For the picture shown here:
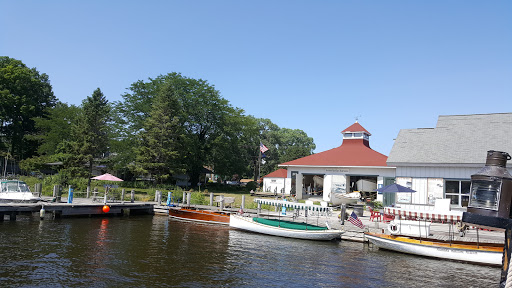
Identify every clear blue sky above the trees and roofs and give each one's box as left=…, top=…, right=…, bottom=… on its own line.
left=0, top=0, right=512, bottom=155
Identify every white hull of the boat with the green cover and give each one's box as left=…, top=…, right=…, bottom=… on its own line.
left=229, top=214, right=343, bottom=240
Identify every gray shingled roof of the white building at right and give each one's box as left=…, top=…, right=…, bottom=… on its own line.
left=387, top=113, right=512, bottom=167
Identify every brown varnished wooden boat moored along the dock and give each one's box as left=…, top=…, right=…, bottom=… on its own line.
left=169, top=207, right=229, bottom=225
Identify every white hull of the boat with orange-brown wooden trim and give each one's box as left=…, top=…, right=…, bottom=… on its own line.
left=365, top=234, right=503, bottom=265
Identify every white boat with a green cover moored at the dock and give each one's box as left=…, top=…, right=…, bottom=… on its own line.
left=229, top=214, right=343, bottom=240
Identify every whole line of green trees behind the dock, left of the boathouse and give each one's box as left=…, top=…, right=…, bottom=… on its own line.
left=0, top=57, right=315, bottom=184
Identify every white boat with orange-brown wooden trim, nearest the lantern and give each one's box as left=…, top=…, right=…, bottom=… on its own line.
left=365, top=232, right=504, bottom=266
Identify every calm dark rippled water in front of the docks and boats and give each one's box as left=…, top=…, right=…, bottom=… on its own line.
left=0, top=216, right=500, bottom=287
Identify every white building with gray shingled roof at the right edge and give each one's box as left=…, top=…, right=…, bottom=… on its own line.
left=385, top=113, right=512, bottom=208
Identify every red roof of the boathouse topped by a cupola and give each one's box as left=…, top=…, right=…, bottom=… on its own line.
left=281, top=139, right=388, bottom=166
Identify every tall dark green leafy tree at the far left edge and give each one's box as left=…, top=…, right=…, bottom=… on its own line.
left=0, top=57, right=56, bottom=160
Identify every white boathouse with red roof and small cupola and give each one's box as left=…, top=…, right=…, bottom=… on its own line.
left=279, top=121, right=395, bottom=202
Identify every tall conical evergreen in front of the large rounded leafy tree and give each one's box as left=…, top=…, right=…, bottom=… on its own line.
left=134, top=85, right=185, bottom=183
